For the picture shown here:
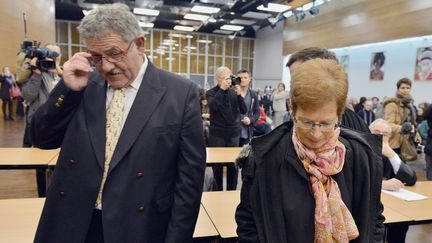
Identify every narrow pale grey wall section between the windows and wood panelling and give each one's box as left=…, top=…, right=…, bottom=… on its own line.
left=252, top=21, right=283, bottom=89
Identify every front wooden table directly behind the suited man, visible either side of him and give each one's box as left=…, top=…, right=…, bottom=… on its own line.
left=0, top=198, right=219, bottom=243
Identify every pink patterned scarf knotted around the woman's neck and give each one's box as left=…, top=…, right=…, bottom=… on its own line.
left=292, top=127, right=359, bottom=243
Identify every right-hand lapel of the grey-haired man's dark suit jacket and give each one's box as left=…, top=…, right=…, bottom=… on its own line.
left=108, top=62, right=166, bottom=173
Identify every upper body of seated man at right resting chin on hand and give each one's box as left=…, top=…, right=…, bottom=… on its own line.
left=369, top=118, right=417, bottom=191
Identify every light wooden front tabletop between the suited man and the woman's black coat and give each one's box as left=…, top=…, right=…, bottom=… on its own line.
left=201, top=190, right=240, bottom=239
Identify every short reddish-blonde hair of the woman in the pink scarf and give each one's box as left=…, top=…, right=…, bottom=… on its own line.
left=290, top=58, right=348, bottom=118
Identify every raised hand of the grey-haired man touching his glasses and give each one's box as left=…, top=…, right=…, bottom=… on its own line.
left=63, top=52, right=93, bottom=91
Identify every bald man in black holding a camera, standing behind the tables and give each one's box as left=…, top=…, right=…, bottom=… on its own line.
left=206, top=67, right=247, bottom=190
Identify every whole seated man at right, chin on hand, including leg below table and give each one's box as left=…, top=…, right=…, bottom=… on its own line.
left=369, top=119, right=417, bottom=243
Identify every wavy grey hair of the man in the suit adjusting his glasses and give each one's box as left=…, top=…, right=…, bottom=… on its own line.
left=78, top=3, right=142, bottom=42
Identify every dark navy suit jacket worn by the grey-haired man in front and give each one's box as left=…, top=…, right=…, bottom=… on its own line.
left=30, top=63, right=205, bottom=243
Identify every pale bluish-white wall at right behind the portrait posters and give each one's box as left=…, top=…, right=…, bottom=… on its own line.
left=282, top=36, right=432, bottom=104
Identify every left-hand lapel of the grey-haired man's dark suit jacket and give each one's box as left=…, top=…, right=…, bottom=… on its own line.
left=84, top=77, right=106, bottom=168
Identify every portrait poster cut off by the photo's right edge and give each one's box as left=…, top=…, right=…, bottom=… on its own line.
left=414, top=46, right=432, bottom=81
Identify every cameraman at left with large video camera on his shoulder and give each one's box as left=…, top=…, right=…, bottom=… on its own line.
left=22, top=44, right=62, bottom=197
